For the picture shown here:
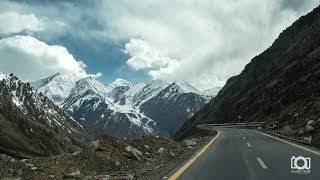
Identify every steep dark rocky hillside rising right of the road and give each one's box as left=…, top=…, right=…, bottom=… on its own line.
left=176, top=7, right=320, bottom=141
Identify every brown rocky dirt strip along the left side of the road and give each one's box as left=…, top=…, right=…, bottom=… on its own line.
left=0, top=131, right=212, bottom=180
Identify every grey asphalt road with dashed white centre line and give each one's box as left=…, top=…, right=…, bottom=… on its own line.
left=168, top=128, right=320, bottom=180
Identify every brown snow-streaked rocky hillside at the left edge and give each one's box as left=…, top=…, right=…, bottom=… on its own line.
left=0, top=73, right=91, bottom=157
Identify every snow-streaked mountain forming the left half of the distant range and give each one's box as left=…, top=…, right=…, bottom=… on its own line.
left=62, top=77, right=158, bottom=137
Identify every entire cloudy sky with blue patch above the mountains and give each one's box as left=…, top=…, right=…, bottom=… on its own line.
left=0, top=0, right=320, bottom=89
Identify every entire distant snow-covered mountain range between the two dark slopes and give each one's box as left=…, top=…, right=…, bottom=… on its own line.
left=31, top=73, right=217, bottom=137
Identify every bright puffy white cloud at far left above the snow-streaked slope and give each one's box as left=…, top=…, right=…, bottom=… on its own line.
left=0, top=35, right=101, bottom=81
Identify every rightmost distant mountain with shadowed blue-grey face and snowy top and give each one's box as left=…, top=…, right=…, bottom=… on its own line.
left=140, top=82, right=210, bottom=135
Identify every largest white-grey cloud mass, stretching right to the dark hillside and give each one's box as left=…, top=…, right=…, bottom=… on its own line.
left=99, top=0, right=319, bottom=89
